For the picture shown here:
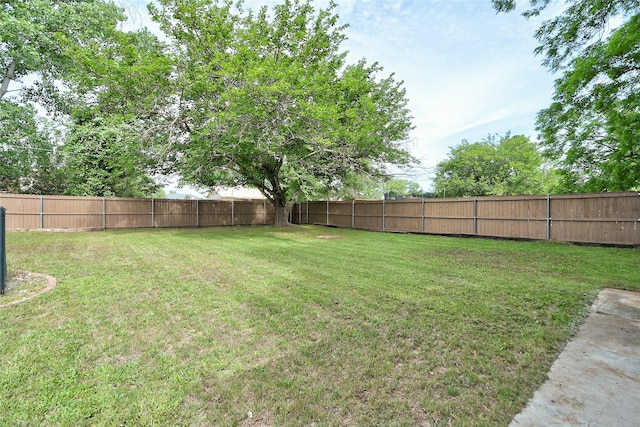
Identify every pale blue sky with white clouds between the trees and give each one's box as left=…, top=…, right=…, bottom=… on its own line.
left=127, top=0, right=554, bottom=190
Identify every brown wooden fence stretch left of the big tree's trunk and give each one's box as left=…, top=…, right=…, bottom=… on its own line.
left=0, top=193, right=274, bottom=230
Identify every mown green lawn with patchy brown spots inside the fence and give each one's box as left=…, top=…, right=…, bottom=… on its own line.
left=0, top=226, right=640, bottom=426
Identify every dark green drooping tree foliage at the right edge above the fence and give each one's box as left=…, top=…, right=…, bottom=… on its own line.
left=492, top=0, right=640, bottom=191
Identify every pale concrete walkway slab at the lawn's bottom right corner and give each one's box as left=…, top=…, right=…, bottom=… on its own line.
left=510, top=289, right=640, bottom=427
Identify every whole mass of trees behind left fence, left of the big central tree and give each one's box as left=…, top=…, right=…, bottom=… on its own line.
left=0, top=0, right=172, bottom=196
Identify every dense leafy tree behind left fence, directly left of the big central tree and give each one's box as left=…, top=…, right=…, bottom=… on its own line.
left=62, top=30, right=175, bottom=197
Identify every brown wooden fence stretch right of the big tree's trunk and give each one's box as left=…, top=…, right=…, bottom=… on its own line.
left=292, top=193, right=640, bottom=247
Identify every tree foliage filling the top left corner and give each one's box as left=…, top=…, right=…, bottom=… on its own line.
left=0, top=0, right=124, bottom=106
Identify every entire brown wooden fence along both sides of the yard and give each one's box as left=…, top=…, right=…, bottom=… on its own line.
left=0, top=193, right=640, bottom=246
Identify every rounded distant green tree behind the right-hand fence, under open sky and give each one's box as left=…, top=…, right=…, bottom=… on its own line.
left=434, top=134, right=554, bottom=197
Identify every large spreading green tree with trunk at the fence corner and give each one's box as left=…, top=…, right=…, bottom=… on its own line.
left=150, top=0, right=413, bottom=226
